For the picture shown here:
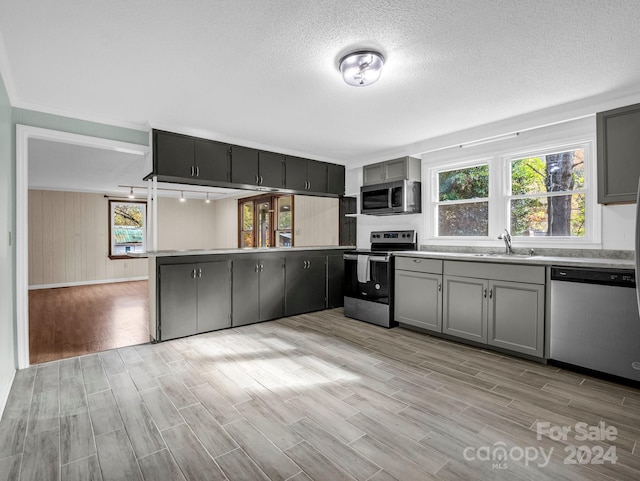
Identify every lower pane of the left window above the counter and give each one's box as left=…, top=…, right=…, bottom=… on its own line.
left=438, top=202, right=489, bottom=236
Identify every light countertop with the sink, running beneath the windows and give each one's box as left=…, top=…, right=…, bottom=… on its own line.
left=394, top=251, right=635, bottom=269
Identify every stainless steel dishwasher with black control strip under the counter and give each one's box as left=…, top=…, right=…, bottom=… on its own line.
left=549, top=267, right=640, bottom=381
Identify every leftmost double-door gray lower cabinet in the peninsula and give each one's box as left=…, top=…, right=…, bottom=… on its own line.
left=158, top=261, right=231, bottom=341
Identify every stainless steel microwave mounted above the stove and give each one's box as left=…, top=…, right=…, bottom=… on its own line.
left=360, top=180, right=422, bottom=215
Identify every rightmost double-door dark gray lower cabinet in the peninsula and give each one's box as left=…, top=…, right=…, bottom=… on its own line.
left=285, top=256, right=327, bottom=316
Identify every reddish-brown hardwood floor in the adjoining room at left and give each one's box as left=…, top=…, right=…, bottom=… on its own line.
left=29, top=281, right=149, bottom=364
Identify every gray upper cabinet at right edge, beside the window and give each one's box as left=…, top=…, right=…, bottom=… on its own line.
left=596, top=104, right=640, bottom=204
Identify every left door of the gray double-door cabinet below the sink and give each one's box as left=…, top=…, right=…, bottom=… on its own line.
left=442, top=276, right=489, bottom=343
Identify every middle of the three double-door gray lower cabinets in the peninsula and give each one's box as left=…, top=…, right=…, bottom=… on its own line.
left=232, top=257, right=284, bottom=327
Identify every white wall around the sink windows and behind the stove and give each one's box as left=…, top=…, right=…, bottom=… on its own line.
left=346, top=116, right=635, bottom=250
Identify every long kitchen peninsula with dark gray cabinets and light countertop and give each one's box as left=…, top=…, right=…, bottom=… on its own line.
left=131, top=246, right=352, bottom=342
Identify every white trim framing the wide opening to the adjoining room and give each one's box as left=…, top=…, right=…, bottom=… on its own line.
left=15, top=125, right=152, bottom=369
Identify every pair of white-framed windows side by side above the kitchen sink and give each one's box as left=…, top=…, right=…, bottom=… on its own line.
left=429, top=142, right=599, bottom=244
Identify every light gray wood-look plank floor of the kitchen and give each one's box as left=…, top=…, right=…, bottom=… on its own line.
left=0, top=309, right=640, bottom=481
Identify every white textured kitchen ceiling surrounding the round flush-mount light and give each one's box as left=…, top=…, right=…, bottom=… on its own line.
left=0, top=0, right=640, bottom=164
